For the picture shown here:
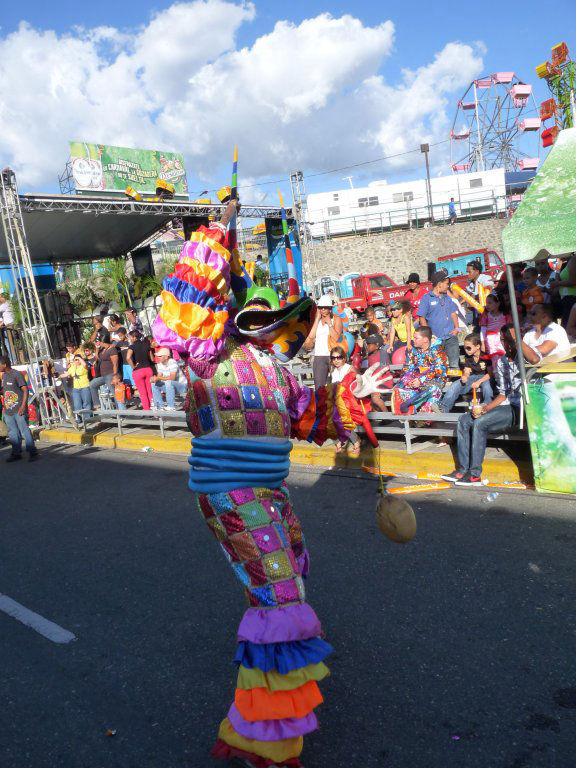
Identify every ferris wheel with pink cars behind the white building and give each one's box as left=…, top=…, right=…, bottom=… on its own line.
left=450, top=72, right=541, bottom=173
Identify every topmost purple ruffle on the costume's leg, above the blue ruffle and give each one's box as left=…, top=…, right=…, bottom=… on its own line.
left=238, top=603, right=322, bottom=644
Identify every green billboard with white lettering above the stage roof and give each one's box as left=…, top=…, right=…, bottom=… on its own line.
left=70, top=141, right=188, bottom=199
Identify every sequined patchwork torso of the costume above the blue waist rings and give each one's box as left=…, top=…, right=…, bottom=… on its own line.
left=186, top=339, right=290, bottom=437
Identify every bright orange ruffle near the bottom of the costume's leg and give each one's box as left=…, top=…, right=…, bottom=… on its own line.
left=234, top=680, right=324, bottom=722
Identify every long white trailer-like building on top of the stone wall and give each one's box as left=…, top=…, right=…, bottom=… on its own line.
left=307, top=168, right=506, bottom=237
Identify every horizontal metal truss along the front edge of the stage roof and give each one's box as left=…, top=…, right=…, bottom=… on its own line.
left=20, top=195, right=292, bottom=219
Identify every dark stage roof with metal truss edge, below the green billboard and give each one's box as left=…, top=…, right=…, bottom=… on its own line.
left=0, top=195, right=291, bottom=264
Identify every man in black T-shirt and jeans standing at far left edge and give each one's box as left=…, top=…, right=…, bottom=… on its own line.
left=0, top=356, right=38, bottom=463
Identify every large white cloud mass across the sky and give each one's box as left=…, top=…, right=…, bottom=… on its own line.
left=0, top=0, right=483, bottom=195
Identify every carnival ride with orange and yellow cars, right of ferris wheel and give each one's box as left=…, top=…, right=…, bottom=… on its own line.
left=536, top=43, right=576, bottom=147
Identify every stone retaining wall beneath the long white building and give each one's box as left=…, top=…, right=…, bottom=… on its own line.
left=310, top=219, right=508, bottom=283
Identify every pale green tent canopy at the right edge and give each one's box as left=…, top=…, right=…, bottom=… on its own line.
left=502, top=128, right=576, bottom=264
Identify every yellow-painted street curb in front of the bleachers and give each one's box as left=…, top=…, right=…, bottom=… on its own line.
left=40, top=429, right=533, bottom=485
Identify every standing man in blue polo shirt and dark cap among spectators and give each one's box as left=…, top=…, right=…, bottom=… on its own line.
left=418, top=269, right=460, bottom=368
